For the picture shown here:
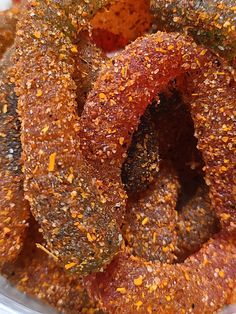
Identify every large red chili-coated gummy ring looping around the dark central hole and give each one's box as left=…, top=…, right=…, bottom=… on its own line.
left=80, top=32, right=236, bottom=313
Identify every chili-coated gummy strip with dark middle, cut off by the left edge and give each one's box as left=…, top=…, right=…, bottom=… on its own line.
left=0, top=47, right=29, bottom=268
